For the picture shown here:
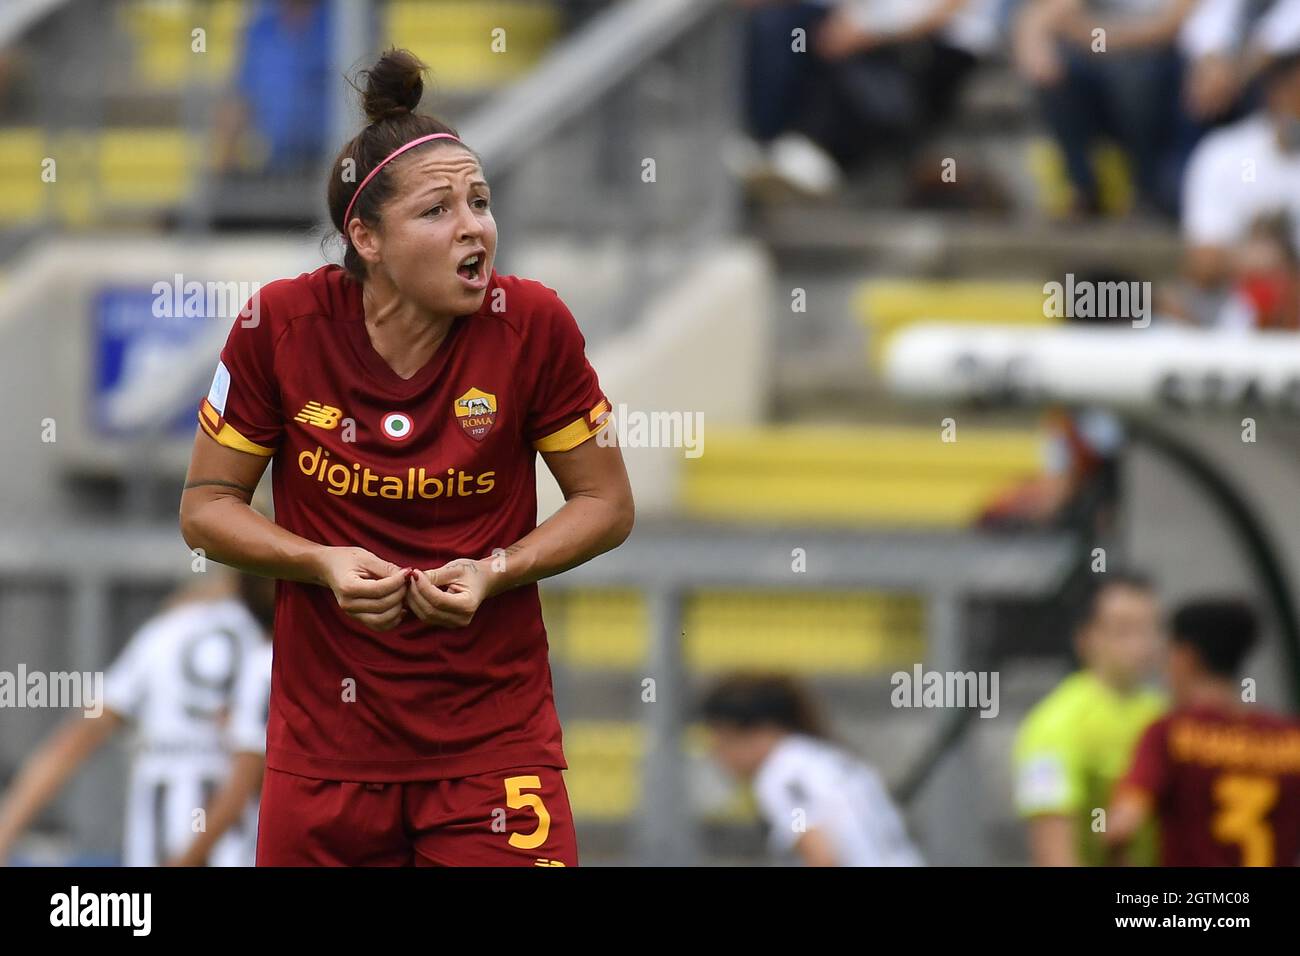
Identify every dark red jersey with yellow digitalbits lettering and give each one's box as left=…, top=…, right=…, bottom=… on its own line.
left=199, top=265, right=610, bottom=782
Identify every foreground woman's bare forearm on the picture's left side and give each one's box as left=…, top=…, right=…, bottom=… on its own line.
left=181, top=488, right=326, bottom=584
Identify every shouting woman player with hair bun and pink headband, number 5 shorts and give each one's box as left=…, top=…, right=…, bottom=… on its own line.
left=181, top=51, right=633, bottom=866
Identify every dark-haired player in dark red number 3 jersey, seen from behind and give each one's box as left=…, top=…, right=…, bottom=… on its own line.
left=1106, top=600, right=1300, bottom=866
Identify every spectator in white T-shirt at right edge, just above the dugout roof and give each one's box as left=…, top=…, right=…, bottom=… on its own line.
left=1183, top=49, right=1300, bottom=304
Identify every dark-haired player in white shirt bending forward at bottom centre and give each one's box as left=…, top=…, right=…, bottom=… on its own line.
left=701, top=674, right=923, bottom=866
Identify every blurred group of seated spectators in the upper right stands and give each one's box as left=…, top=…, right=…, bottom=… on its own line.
left=732, top=0, right=1300, bottom=329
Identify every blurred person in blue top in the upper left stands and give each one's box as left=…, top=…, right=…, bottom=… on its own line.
left=215, top=0, right=332, bottom=174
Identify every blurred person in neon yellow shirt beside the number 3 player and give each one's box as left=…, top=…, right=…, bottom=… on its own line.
left=1015, top=571, right=1165, bottom=866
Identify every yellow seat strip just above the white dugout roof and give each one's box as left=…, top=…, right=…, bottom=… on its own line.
left=853, top=280, right=1060, bottom=369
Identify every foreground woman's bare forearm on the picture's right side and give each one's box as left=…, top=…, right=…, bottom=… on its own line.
left=478, top=494, right=634, bottom=596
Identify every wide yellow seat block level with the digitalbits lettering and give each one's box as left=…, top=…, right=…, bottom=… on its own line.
left=681, top=423, right=1041, bottom=528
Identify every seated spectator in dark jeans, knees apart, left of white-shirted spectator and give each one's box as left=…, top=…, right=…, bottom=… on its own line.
left=1014, top=0, right=1197, bottom=216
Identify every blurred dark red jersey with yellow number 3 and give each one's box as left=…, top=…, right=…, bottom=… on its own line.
left=1119, top=706, right=1300, bottom=866
